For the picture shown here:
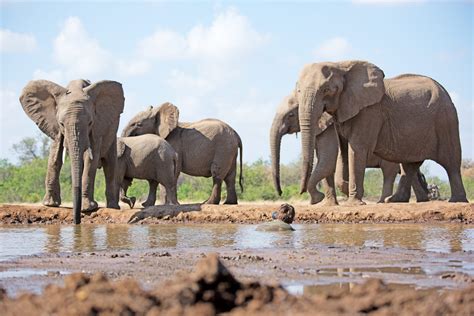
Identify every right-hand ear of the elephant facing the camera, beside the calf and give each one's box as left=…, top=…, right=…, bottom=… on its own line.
left=84, top=80, right=125, bottom=135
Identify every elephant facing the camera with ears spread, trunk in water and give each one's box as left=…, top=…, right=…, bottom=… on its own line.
left=20, top=80, right=125, bottom=224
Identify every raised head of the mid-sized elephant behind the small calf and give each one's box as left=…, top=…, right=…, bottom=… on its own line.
left=122, top=102, right=179, bottom=138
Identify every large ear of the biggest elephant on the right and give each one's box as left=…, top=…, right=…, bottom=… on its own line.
left=336, top=61, right=385, bottom=123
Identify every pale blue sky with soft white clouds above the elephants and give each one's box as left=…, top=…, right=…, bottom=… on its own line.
left=0, top=0, right=474, bottom=178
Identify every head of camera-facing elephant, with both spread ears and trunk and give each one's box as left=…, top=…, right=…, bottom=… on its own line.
left=20, top=80, right=125, bottom=223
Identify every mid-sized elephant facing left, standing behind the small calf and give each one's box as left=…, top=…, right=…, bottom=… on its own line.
left=122, top=102, right=243, bottom=204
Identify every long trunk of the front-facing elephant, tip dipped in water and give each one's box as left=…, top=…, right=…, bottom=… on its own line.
left=65, top=125, right=88, bottom=224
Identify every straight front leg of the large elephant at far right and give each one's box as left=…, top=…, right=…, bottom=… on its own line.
left=347, top=144, right=367, bottom=205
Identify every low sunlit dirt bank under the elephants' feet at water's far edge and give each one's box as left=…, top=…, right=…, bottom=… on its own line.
left=0, top=201, right=474, bottom=224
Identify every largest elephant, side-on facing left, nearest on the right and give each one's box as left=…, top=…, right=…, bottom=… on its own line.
left=296, top=61, right=467, bottom=204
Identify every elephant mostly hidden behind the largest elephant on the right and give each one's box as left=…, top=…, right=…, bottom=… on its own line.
left=270, top=93, right=429, bottom=205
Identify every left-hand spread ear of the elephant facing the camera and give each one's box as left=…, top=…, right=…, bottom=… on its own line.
left=20, top=80, right=67, bottom=139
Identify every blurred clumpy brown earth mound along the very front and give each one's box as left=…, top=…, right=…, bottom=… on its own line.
left=0, top=254, right=474, bottom=315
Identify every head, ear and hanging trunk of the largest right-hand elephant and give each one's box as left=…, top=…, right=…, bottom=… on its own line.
left=296, top=61, right=385, bottom=192
